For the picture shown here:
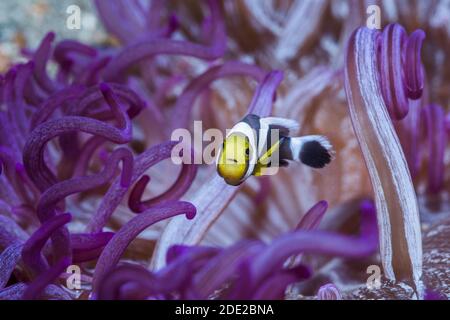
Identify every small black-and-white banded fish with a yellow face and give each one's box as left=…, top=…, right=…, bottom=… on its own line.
left=216, top=114, right=333, bottom=186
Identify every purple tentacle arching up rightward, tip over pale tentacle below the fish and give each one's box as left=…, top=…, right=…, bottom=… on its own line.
left=92, top=201, right=196, bottom=291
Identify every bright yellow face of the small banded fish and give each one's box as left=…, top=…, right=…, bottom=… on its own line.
left=217, top=134, right=251, bottom=186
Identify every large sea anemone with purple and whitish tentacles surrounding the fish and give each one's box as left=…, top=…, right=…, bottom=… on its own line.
left=0, top=0, right=450, bottom=300
